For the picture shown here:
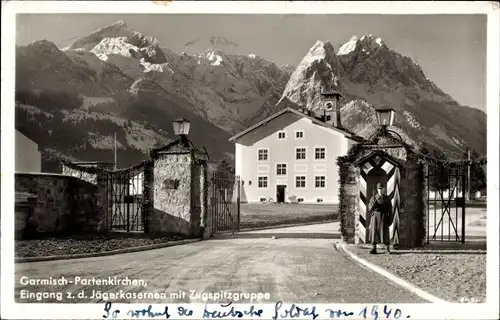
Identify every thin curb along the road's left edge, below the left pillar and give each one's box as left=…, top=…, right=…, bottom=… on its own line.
left=14, top=239, right=203, bottom=263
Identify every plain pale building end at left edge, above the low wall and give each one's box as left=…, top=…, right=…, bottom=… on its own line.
left=15, top=130, right=42, bottom=172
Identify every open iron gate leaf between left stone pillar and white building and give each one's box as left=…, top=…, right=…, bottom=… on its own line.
left=209, top=172, right=240, bottom=235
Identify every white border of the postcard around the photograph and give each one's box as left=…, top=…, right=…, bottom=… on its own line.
left=1, top=1, right=500, bottom=319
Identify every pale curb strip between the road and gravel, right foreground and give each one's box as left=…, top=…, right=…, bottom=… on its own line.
left=335, top=242, right=450, bottom=303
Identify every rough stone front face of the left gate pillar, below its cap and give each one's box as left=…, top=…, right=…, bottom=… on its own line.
left=147, top=153, right=193, bottom=235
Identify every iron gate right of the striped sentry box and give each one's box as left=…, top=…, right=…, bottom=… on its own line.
left=426, top=162, right=467, bottom=243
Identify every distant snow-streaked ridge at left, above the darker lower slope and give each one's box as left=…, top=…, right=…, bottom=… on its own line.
left=60, top=21, right=290, bottom=133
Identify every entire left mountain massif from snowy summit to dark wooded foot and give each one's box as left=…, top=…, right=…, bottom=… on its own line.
left=16, top=21, right=290, bottom=168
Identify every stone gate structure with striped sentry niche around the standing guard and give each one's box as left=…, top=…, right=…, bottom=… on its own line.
left=337, top=128, right=427, bottom=248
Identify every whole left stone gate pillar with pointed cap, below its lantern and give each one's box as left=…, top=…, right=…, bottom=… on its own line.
left=147, top=137, right=207, bottom=237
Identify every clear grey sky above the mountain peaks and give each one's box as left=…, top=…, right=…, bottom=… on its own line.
left=16, top=14, right=487, bottom=112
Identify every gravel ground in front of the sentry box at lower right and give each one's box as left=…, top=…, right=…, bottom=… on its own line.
left=349, top=245, right=486, bottom=303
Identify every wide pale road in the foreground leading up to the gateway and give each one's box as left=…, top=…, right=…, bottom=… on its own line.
left=15, top=238, right=424, bottom=303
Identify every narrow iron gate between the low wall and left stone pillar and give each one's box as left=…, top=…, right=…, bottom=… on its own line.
left=104, top=168, right=145, bottom=232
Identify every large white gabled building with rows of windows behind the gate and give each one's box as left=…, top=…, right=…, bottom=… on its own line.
left=230, top=107, right=359, bottom=204
